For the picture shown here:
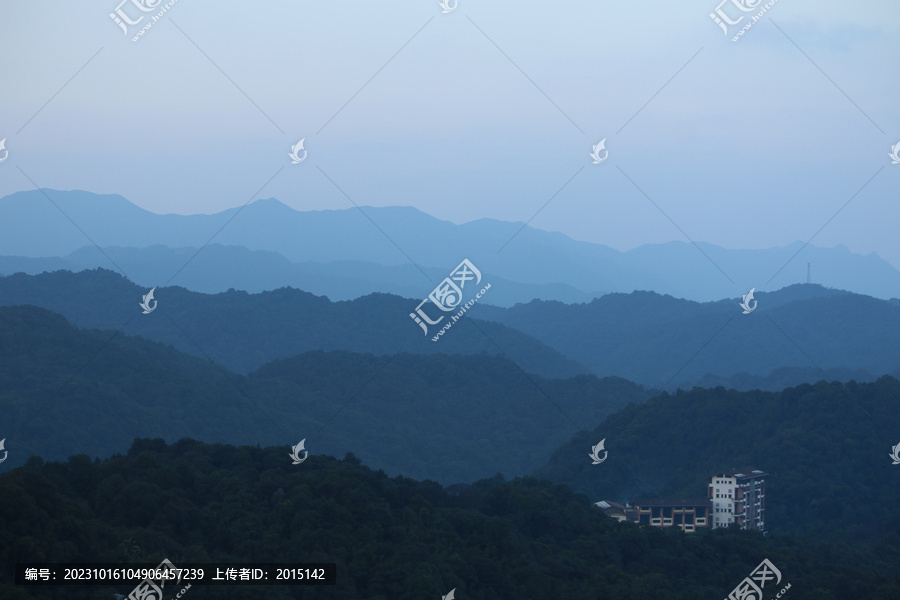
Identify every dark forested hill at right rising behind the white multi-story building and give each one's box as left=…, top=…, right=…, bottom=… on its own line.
left=536, top=376, right=900, bottom=539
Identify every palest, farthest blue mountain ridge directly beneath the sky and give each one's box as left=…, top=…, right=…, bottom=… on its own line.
left=0, top=189, right=900, bottom=305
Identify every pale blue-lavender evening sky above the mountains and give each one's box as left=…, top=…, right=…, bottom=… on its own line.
left=0, top=0, right=900, bottom=268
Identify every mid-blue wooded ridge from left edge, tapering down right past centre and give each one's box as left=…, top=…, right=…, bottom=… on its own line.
left=0, top=269, right=590, bottom=378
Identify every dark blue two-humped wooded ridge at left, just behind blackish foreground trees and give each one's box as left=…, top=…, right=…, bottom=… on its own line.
left=0, top=306, right=650, bottom=484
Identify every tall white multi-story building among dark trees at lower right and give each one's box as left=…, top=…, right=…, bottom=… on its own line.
left=708, top=469, right=768, bottom=532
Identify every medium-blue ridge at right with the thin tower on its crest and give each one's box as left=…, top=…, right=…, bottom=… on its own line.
left=472, top=284, right=900, bottom=389
